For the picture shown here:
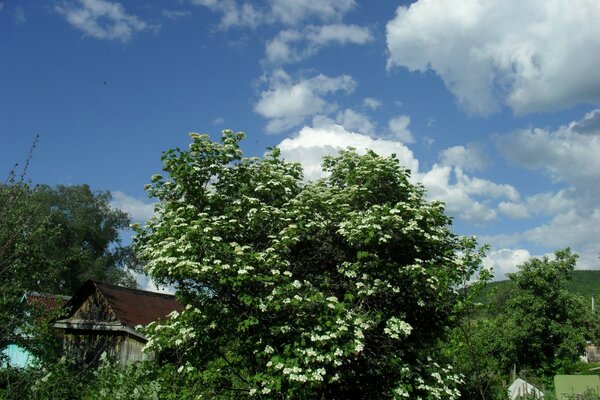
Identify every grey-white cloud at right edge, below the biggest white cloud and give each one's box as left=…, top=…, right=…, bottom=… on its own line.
left=495, top=110, right=600, bottom=209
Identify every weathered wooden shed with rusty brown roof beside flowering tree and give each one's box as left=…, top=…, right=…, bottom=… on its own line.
left=54, top=281, right=183, bottom=365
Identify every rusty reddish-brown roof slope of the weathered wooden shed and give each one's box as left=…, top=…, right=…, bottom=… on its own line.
left=94, top=282, right=183, bottom=328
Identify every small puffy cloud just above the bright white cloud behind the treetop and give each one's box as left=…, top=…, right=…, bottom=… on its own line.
left=254, top=70, right=356, bottom=133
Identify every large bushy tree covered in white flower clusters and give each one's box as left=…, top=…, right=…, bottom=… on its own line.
left=136, top=131, right=479, bottom=399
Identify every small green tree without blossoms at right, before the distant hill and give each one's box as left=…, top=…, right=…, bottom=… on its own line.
left=488, top=248, right=600, bottom=376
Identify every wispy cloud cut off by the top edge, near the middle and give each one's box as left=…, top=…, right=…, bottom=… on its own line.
left=192, top=0, right=356, bottom=29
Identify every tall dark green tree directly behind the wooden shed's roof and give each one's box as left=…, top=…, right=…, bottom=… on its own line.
left=26, top=185, right=135, bottom=294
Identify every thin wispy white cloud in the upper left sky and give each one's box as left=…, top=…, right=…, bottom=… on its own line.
left=54, top=0, right=158, bottom=43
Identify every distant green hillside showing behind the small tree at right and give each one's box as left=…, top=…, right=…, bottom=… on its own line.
left=477, top=270, right=600, bottom=310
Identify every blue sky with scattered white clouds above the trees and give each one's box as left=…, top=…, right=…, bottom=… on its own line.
left=0, top=0, right=600, bottom=278
